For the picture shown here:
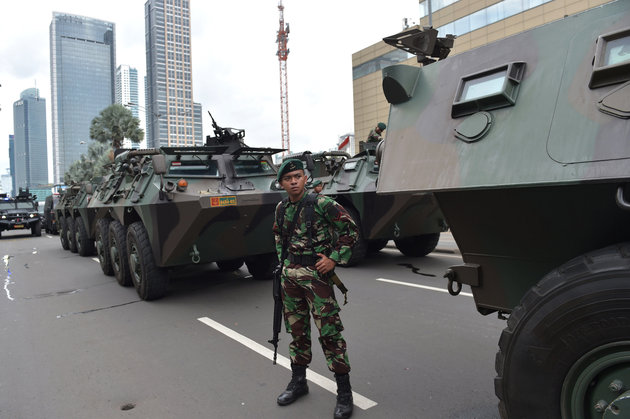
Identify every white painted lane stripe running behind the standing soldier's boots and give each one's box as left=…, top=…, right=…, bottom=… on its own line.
left=197, top=317, right=378, bottom=410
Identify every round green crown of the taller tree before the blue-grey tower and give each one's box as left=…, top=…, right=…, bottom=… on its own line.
left=90, top=103, right=144, bottom=150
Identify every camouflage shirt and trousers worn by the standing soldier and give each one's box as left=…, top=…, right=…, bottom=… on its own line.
left=273, top=193, right=359, bottom=374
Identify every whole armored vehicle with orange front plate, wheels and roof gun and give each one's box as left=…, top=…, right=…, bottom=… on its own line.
left=83, top=119, right=284, bottom=300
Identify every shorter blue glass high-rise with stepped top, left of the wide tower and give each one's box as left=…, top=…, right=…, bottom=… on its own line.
left=13, top=88, right=48, bottom=189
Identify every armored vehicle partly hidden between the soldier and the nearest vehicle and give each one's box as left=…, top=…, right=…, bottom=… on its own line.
left=285, top=142, right=448, bottom=265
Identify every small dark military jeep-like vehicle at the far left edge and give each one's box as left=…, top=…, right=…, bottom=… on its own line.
left=0, top=188, right=42, bottom=236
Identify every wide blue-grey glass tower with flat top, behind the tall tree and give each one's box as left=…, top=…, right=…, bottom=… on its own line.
left=50, top=12, right=116, bottom=182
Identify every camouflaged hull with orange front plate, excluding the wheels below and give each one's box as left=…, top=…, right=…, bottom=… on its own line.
left=88, top=129, right=286, bottom=267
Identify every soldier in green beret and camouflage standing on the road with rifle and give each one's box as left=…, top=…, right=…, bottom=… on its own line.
left=273, top=159, right=359, bottom=418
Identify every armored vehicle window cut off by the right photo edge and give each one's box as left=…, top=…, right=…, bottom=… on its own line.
left=588, top=28, right=630, bottom=89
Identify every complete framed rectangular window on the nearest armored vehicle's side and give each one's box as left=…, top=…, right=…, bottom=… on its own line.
left=451, top=62, right=525, bottom=118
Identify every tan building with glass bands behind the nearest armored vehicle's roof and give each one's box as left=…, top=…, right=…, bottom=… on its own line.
left=352, top=0, right=610, bottom=152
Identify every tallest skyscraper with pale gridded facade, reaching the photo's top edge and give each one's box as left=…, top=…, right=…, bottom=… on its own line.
left=144, top=0, right=202, bottom=147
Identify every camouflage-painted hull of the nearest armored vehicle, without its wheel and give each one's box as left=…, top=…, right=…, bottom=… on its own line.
left=377, top=1, right=630, bottom=314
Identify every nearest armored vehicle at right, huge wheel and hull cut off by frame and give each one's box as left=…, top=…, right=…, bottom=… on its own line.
left=378, top=0, right=630, bottom=419
